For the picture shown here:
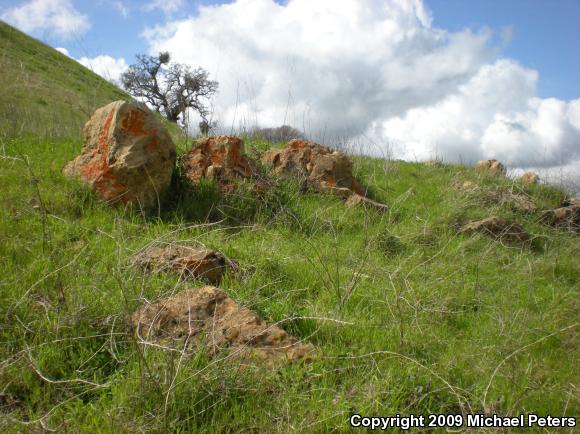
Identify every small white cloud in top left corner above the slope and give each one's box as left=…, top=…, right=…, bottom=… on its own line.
left=0, top=0, right=91, bottom=39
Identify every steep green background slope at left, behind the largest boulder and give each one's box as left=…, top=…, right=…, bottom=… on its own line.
left=0, top=21, right=130, bottom=137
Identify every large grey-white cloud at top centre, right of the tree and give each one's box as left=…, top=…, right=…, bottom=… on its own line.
left=145, top=0, right=493, bottom=134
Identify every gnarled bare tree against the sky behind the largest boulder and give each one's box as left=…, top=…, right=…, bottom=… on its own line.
left=121, top=52, right=218, bottom=124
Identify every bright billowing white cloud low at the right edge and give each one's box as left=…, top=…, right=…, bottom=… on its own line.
left=374, top=59, right=580, bottom=166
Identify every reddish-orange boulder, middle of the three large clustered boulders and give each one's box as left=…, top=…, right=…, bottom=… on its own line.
left=181, top=136, right=257, bottom=189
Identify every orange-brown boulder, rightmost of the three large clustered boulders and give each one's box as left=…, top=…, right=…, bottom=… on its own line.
left=262, top=139, right=364, bottom=196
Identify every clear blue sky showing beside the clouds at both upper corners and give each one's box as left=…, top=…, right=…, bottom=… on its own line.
left=0, top=0, right=580, bottom=99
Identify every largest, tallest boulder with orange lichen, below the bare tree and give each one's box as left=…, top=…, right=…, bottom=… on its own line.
left=63, top=101, right=176, bottom=208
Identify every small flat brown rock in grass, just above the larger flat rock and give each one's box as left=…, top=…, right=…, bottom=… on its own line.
left=133, top=244, right=227, bottom=284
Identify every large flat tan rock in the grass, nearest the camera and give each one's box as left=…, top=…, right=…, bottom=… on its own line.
left=130, top=286, right=313, bottom=365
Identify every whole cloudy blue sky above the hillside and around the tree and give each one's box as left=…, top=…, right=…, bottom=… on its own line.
left=0, top=0, right=580, bottom=185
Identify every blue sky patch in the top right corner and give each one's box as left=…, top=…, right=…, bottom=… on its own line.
left=427, top=0, right=580, bottom=99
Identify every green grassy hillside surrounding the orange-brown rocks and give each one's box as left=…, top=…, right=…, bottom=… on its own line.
left=0, top=21, right=580, bottom=433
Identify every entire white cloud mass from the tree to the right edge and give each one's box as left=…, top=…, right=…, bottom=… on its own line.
left=144, top=0, right=580, bottom=176
